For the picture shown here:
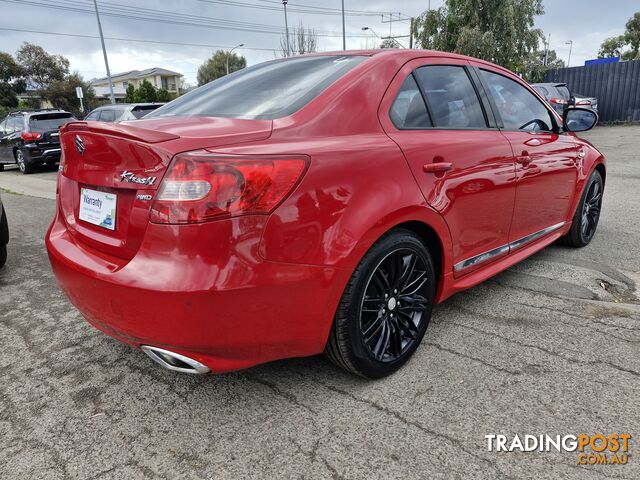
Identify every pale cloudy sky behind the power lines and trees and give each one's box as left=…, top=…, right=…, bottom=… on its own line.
left=0, top=0, right=640, bottom=84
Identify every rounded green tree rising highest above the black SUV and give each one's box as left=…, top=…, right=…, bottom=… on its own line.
left=16, top=42, right=69, bottom=90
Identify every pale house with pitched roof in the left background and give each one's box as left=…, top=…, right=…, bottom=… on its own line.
left=89, top=68, right=182, bottom=100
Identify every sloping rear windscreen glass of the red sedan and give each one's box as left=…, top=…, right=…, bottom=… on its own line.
left=145, top=56, right=367, bottom=120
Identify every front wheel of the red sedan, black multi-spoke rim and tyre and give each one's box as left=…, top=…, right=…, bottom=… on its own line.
left=561, top=170, right=604, bottom=247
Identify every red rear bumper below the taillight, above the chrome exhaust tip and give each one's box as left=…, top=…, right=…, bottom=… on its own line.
left=46, top=209, right=344, bottom=373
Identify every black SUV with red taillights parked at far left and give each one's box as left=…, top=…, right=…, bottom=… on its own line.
left=0, top=110, right=76, bottom=173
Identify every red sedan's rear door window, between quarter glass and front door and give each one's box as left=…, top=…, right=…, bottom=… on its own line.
left=415, top=65, right=487, bottom=128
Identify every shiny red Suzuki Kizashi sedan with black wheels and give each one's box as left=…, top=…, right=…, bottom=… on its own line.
left=46, top=50, right=605, bottom=378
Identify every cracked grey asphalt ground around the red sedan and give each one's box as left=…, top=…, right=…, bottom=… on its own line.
left=0, top=126, right=640, bottom=479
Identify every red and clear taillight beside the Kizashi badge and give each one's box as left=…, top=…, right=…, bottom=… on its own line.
left=151, top=151, right=308, bottom=223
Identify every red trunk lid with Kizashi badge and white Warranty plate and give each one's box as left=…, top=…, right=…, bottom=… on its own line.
left=58, top=117, right=272, bottom=259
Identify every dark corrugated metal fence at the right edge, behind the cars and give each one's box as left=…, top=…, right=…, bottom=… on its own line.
left=544, top=60, right=640, bottom=122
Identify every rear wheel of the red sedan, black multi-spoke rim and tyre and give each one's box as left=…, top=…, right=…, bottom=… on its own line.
left=324, top=229, right=436, bottom=378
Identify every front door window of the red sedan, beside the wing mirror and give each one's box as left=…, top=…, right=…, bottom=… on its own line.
left=480, top=70, right=553, bottom=131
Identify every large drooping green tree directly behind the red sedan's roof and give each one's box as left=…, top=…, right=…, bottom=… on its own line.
left=412, top=0, right=544, bottom=71
